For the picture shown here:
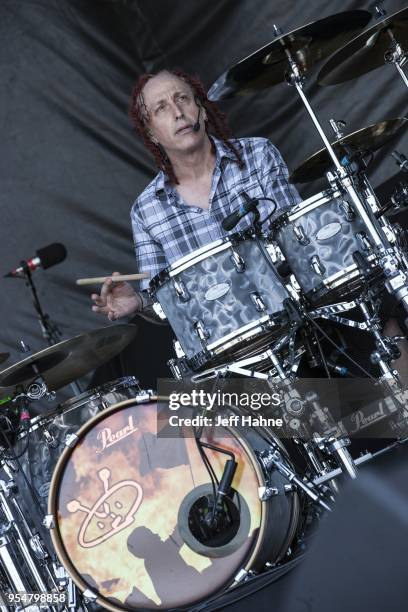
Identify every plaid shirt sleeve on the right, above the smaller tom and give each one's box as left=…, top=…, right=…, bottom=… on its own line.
left=260, top=140, right=302, bottom=210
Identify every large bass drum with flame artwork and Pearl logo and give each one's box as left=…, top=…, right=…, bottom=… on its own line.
left=49, top=393, right=299, bottom=611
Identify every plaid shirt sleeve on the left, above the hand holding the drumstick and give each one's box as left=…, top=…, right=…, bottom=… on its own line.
left=130, top=200, right=166, bottom=291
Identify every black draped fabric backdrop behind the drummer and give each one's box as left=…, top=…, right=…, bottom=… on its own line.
left=0, top=0, right=408, bottom=392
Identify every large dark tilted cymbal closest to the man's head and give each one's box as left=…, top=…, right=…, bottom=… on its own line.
left=208, top=10, right=371, bottom=100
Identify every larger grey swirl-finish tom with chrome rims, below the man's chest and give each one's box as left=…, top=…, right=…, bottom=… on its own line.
left=150, top=234, right=289, bottom=369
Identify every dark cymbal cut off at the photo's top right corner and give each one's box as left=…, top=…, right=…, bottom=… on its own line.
left=317, top=8, right=408, bottom=86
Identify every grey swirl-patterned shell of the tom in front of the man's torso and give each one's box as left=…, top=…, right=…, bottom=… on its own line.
left=154, top=234, right=288, bottom=358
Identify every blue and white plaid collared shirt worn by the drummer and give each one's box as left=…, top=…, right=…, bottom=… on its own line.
left=131, top=137, right=300, bottom=289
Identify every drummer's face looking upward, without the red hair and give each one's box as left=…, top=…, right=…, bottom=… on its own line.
left=143, top=72, right=205, bottom=154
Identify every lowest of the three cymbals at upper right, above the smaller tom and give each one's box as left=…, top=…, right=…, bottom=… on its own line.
left=289, top=117, right=408, bottom=183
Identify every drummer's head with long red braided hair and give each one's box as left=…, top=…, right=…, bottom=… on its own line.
left=129, top=70, right=240, bottom=183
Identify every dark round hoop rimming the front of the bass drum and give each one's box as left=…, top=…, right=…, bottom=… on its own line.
left=48, top=395, right=276, bottom=612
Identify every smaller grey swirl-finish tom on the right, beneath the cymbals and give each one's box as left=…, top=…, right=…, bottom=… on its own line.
left=272, top=190, right=380, bottom=304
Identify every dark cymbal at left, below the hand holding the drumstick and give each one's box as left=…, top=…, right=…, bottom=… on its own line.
left=0, top=324, right=137, bottom=391
